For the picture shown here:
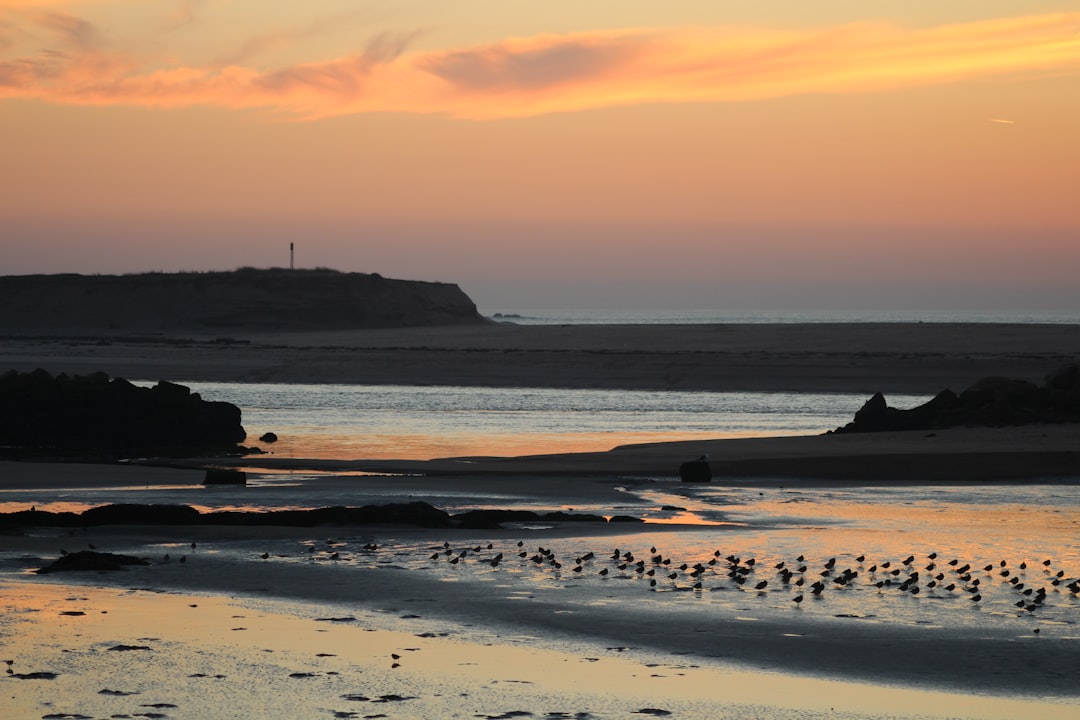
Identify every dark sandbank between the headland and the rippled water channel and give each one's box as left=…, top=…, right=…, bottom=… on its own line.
left=8, top=323, right=1080, bottom=396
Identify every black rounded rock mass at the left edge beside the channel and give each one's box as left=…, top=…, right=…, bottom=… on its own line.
left=0, top=370, right=246, bottom=460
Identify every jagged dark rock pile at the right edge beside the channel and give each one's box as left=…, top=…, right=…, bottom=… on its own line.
left=835, top=365, right=1080, bottom=433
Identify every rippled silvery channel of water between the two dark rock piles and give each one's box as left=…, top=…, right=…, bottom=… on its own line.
left=156, top=382, right=930, bottom=460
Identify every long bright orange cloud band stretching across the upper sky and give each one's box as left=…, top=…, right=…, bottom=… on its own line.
left=6, top=13, right=1080, bottom=119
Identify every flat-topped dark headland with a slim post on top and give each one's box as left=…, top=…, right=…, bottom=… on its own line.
left=0, top=269, right=487, bottom=336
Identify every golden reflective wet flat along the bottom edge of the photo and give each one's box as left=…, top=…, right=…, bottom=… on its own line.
left=0, top=583, right=1076, bottom=720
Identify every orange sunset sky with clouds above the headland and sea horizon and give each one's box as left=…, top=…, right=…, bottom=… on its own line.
left=0, top=0, right=1080, bottom=312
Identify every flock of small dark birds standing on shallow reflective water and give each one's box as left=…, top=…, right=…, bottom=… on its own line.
left=414, top=541, right=1080, bottom=613
